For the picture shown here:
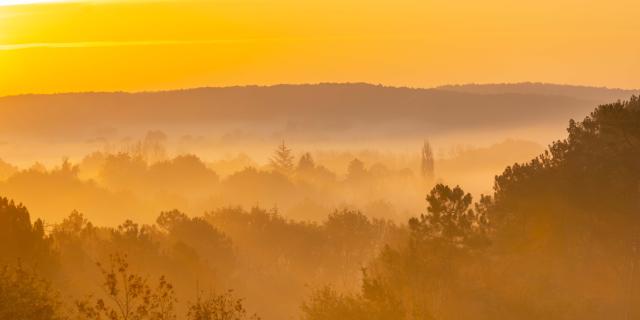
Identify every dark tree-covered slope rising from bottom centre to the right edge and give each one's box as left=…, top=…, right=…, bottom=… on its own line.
left=303, top=97, right=640, bottom=319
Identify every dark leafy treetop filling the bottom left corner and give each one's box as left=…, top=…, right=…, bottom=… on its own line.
left=0, top=264, right=66, bottom=320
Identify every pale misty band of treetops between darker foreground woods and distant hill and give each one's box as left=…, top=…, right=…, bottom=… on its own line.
left=0, top=131, right=543, bottom=226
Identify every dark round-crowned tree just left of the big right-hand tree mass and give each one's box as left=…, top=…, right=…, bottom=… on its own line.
left=363, top=184, right=488, bottom=319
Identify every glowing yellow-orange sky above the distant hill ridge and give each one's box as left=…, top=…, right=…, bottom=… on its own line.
left=0, top=0, right=640, bottom=96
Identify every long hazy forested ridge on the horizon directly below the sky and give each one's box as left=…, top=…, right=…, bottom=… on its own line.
left=0, top=84, right=635, bottom=136
